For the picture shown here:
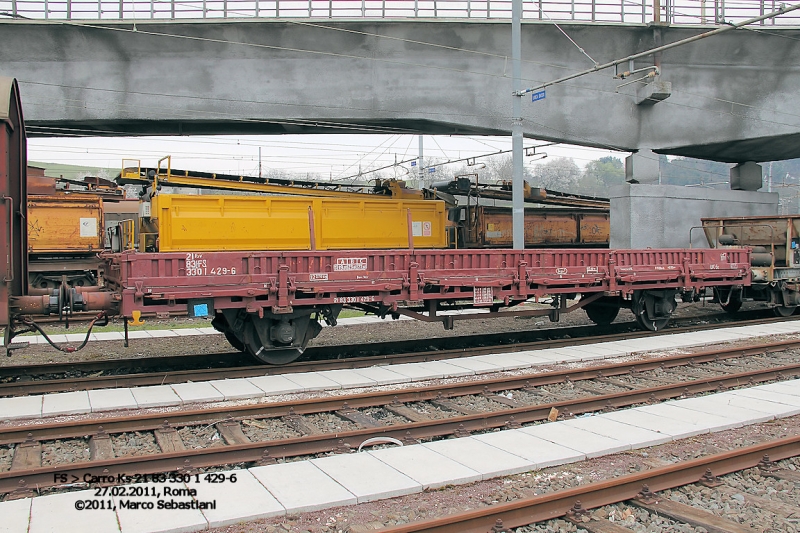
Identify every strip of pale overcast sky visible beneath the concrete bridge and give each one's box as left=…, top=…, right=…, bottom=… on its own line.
left=28, top=135, right=628, bottom=179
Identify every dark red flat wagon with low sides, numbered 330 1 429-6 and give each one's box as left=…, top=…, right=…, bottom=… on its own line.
left=101, top=245, right=750, bottom=363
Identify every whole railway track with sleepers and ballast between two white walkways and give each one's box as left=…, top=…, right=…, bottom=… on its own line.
left=0, top=341, right=800, bottom=495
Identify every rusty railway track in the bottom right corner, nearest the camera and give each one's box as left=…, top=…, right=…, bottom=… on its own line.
left=381, top=437, right=800, bottom=533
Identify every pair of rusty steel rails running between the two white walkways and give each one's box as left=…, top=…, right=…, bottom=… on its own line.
left=0, top=342, right=800, bottom=492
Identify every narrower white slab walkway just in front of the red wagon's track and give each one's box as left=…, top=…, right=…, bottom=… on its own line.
left=0, top=321, right=800, bottom=420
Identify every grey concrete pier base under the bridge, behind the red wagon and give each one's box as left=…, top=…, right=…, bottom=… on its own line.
left=610, top=184, right=778, bottom=248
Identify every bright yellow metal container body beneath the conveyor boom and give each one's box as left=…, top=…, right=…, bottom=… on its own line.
left=151, top=194, right=447, bottom=252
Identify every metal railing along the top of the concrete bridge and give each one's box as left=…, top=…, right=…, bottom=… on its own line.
left=6, top=0, right=800, bottom=26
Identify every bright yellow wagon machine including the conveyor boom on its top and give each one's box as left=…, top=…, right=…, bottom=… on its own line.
left=126, top=157, right=448, bottom=252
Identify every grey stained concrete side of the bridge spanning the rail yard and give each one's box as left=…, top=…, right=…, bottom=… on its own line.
left=0, top=19, right=800, bottom=162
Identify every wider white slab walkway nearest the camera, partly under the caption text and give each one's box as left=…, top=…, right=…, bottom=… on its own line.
left=0, top=380, right=800, bottom=533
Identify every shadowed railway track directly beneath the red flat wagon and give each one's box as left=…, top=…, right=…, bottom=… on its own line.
left=0, top=312, right=795, bottom=397
